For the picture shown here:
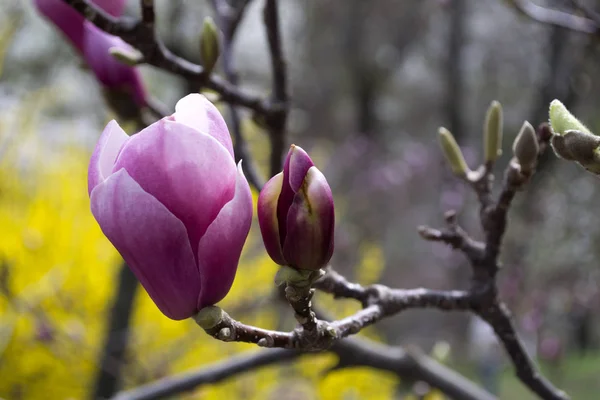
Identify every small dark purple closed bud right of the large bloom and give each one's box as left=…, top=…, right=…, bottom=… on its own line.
left=258, top=145, right=335, bottom=270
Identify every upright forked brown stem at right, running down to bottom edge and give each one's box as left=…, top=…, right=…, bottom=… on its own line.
left=420, top=124, right=568, bottom=400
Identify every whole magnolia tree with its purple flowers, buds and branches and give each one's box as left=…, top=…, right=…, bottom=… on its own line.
left=35, top=0, right=600, bottom=399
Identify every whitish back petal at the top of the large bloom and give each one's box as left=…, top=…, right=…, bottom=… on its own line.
left=174, top=93, right=233, bottom=158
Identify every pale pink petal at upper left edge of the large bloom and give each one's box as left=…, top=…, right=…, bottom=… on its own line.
left=88, top=120, right=129, bottom=195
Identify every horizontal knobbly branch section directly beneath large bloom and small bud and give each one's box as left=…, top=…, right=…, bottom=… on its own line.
left=196, top=272, right=473, bottom=351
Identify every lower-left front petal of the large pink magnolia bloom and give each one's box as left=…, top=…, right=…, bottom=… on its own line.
left=91, top=169, right=200, bottom=320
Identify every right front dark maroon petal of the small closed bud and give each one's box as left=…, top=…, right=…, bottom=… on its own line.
left=283, top=167, right=335, bottom=270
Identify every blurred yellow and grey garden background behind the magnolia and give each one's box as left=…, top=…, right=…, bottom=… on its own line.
left=0, top=0, right=600, bottom=400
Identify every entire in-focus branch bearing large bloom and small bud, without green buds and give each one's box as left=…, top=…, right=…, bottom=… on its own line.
left=191, top=125, right=568, bottom=400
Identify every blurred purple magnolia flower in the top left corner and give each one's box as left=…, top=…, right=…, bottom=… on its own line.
left=34, top=0, right=146, bottom=107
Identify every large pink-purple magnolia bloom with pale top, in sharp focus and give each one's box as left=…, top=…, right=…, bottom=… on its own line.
left=88, top=94, right=252, bottom=320
